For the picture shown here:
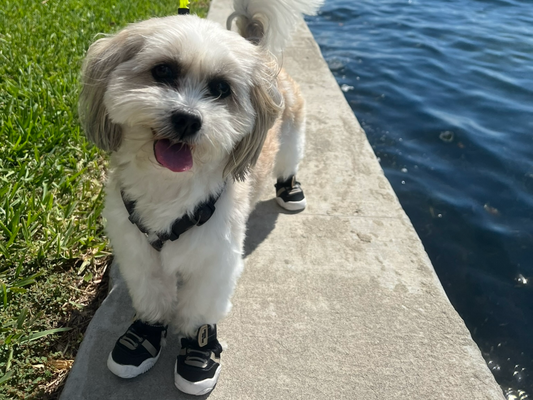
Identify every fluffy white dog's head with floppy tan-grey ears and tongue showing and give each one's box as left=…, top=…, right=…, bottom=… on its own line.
left=80, top=16, right=281, bottom=179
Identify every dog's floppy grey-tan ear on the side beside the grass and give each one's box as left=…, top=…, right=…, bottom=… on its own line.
left=78, top=28, right=144, bottom=151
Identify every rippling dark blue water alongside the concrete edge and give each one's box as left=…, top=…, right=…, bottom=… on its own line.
left=308, top=0, right=533, bottom=399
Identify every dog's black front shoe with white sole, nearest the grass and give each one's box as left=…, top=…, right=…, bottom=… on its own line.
left=107, top=320, right=167, bottom=378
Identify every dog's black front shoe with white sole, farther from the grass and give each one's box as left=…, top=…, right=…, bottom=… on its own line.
left=174, top=325, right=222, bottom=396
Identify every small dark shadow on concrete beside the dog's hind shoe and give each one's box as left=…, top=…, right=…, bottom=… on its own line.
left=244, top=199, right=285, bottom=258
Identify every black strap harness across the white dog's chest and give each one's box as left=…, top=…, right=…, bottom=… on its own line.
left=120, top=189, right=224, bottom=251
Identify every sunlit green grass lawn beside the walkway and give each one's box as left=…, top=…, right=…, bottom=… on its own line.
left=0, top=0, right=209, bottom=399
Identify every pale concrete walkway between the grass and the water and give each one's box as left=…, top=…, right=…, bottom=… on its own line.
left=61, top=0, right=504, bottom=400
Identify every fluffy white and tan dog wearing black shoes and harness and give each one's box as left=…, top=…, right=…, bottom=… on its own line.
left=80, top=0, right=322, bottom=395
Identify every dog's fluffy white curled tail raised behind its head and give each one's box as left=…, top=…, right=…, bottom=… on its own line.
left=226, top=0, right=324, bottom=54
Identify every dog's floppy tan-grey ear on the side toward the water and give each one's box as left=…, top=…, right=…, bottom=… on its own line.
left=224, top=66, right=283, bottom=181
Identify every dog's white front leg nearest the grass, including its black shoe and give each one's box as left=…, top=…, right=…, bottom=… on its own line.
left=104, top=190, right=177, bottom=378
